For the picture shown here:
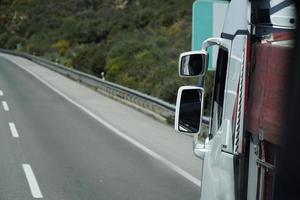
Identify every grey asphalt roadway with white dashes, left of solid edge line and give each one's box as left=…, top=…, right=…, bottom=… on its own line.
left=0, top=55, right=200, bottom=200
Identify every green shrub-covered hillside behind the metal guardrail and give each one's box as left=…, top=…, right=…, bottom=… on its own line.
left=0, top=0, right=216, bottom=111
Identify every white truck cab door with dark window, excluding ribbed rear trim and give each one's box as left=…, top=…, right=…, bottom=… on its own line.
left=201, top=42, right=239, bottom=200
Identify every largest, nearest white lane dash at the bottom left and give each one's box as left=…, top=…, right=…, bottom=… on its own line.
left=22, top=164, right=43, bottom=199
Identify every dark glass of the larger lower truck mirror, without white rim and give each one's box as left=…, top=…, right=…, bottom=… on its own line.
left=178, top=89, right=203, bottom=134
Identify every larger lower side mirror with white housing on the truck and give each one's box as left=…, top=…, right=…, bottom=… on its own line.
left=175, top=86, right=204, bottom=135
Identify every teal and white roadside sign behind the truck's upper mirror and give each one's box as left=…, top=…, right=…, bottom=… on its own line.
left=192, top=0, right=228, bottom=70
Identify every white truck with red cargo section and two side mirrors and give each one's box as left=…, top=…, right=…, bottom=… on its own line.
left=174, top=0, right=297, bottom=200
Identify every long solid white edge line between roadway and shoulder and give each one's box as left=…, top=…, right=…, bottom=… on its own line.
left=18, top=61, right=201, bottom=187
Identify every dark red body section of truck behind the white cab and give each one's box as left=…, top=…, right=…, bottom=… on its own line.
left=247, top=34, right=293, bottom=144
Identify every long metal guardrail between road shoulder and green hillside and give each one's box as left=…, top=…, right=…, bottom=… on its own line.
left=0, top=48, right=209, bottom=125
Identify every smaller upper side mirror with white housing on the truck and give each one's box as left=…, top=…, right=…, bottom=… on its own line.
left=178, top=50, right=208, bottom=77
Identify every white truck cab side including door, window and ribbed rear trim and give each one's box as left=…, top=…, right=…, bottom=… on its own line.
left=201, top=32, right=248, bottom=200
